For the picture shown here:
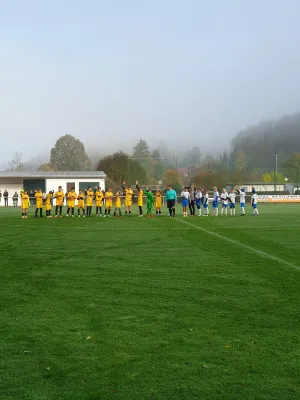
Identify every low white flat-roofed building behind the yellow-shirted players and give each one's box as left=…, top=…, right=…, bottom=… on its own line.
left=0, top=171, right=106, bottom=206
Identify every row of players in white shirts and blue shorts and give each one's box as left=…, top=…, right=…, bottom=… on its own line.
left=181, top=186, right=259, bottom=217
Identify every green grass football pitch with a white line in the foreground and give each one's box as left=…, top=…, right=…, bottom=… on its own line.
left=0, top=205, right=300, bottom=400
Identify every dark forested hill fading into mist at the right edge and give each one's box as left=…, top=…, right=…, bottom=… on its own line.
left=231, top=113, right=300, bottom=169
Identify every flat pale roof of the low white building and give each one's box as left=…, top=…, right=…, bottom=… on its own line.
left=0, top=171, right=106, bottom=179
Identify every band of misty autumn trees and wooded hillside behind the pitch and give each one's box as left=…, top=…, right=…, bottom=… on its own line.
left=3, top=113, right=300, bottom=189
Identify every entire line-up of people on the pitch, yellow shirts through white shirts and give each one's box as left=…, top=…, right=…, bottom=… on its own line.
left=21, top=181, right=259, bottom=218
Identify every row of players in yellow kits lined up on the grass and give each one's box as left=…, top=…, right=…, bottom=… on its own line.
left=20, top=181, right=162, bottom=218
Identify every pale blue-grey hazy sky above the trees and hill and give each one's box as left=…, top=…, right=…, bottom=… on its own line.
left=0, top=0, right=300, bottom=160
